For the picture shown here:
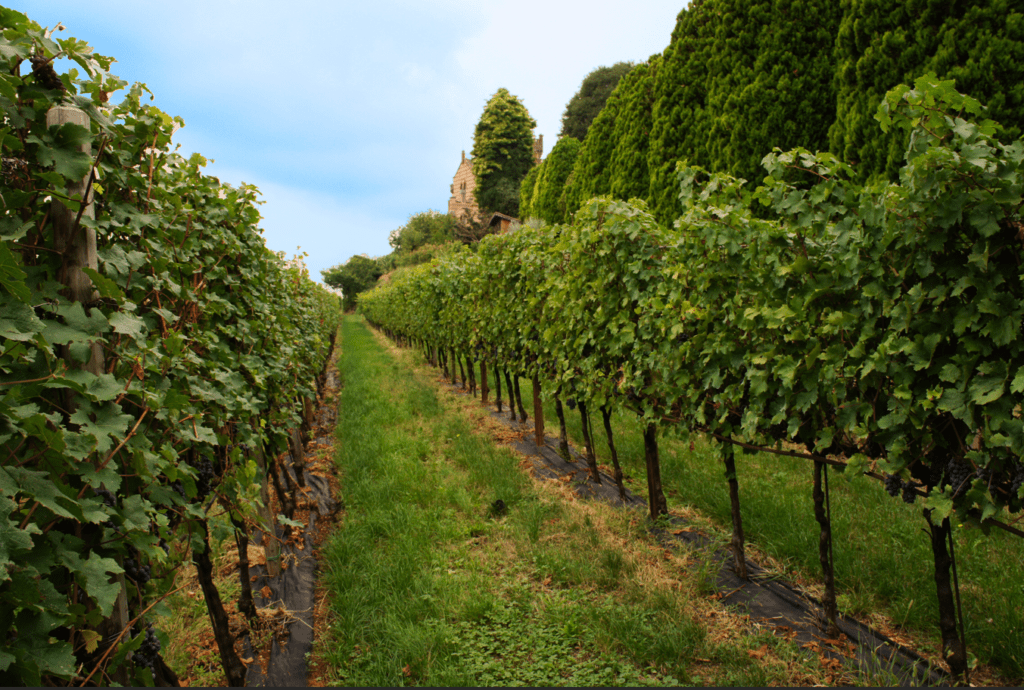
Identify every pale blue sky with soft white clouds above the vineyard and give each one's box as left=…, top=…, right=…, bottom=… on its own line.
left=9, top=0, right=686, bottom=281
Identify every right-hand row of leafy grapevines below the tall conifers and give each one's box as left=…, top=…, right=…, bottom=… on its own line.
left=360, top=78, right=1024, bottom=675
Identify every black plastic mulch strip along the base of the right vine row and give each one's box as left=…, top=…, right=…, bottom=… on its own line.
left=468, top=385, right=949, bottom=686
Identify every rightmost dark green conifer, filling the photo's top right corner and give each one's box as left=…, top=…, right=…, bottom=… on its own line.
left=829, top=0, right=1024, bottom=179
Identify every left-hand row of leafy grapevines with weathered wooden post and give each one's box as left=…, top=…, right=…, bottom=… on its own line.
left=0, top=8, right=339, bottom=686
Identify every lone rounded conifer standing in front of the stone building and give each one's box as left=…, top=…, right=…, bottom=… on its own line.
left=473, top=89, right=537, bottom=216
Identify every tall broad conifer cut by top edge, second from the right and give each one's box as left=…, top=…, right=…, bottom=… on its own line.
left=648, top=0, right=841, bottom=222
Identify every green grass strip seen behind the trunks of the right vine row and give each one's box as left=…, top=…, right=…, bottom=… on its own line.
left=512, top=370, right=1024, bottom=680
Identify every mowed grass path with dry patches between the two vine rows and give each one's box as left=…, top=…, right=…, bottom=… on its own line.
left=317, top=317, right=823, bottom=686
